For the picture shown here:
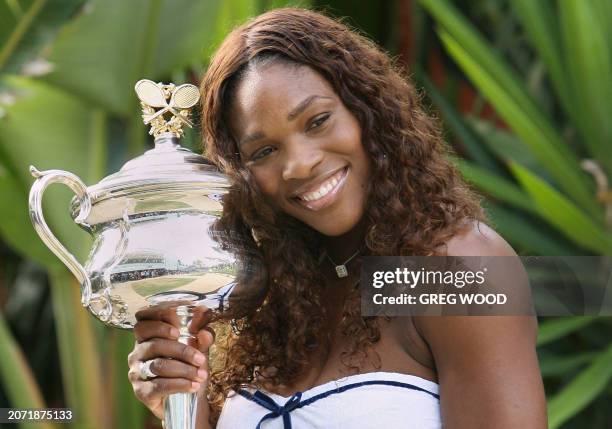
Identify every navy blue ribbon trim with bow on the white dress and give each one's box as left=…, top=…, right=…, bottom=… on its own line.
left=238, top=380, right=440, bottom=429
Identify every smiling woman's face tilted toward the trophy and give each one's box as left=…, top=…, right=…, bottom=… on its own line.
left=231, top=62, right=370, bottom=236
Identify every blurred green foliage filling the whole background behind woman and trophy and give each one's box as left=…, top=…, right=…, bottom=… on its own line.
left=0, top=0, right=612, bottom=428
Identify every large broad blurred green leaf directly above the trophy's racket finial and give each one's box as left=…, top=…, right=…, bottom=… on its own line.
left=46, top=0, right=221, bottom=117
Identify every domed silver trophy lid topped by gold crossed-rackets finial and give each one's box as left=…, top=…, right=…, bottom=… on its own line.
left=72, top=79, right=230, bottom=224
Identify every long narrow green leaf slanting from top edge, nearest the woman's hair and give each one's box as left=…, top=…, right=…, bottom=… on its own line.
left=421, top=0, right=602, bottom=219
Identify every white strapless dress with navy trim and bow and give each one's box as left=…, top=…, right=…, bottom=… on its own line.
left=217, top=371, right=442, bottom=429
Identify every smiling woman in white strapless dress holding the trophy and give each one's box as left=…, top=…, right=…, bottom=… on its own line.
left=129, top=9, right=546, bottom=429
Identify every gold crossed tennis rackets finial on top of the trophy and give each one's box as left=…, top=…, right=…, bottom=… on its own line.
left=134, top=79, right=200, bottom=135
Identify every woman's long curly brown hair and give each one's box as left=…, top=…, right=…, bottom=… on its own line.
left=201, top=8, right=485, bottom=420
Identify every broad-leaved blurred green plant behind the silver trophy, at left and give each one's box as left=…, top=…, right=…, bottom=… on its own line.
left=0, top=0, right=304, bottom=429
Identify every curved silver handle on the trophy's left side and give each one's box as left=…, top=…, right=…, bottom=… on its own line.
left=30, top=166, right=91, bottom=307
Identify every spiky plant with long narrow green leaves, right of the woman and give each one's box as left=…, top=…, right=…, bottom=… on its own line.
left=417, top=0, right=612, bottom=428
